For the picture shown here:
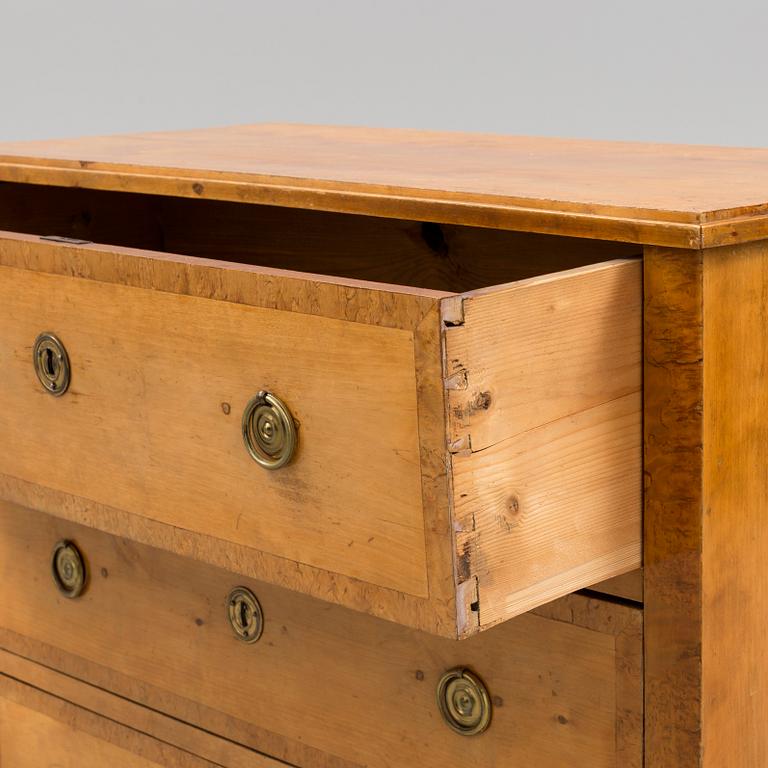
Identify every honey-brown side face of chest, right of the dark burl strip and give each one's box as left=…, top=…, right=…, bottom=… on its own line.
left=701, top=242, right=768, bottom=768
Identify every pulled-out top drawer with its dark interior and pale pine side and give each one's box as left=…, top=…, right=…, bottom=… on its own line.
left=0, top=184, right=642, bottom=637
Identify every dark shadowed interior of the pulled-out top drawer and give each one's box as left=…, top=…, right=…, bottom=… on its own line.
left=0, top=183, right=641, bottom=293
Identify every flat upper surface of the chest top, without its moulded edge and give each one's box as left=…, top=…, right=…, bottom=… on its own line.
left=0, top=124, right=752, bottom=213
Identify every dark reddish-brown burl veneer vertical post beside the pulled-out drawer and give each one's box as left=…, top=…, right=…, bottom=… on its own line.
left=644, top=248, right=704, bottom=768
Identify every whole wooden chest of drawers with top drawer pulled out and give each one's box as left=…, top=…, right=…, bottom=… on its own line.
left=0, top=126, right=768, bottom=768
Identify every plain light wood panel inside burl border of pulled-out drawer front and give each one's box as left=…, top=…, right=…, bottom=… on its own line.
left=0, top=267, right=428, bottom=597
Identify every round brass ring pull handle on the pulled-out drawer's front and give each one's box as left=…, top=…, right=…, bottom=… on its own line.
left=243, top=392, right=297, bottom=469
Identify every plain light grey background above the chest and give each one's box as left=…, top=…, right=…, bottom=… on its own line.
left=0, top=0, right=768, bottom=146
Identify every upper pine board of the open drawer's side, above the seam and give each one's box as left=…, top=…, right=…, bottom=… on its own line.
left=446, top=260, right=642, bottom=451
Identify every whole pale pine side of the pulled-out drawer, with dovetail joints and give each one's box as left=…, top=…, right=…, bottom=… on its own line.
left=446, top=261, right=642, bottom=626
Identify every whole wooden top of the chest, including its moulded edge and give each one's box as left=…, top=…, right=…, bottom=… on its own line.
left=0, top=125, right=768, bottom=247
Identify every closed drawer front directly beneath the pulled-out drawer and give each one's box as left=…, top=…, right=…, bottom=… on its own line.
left=0, top=503, right=642, bottom=768
